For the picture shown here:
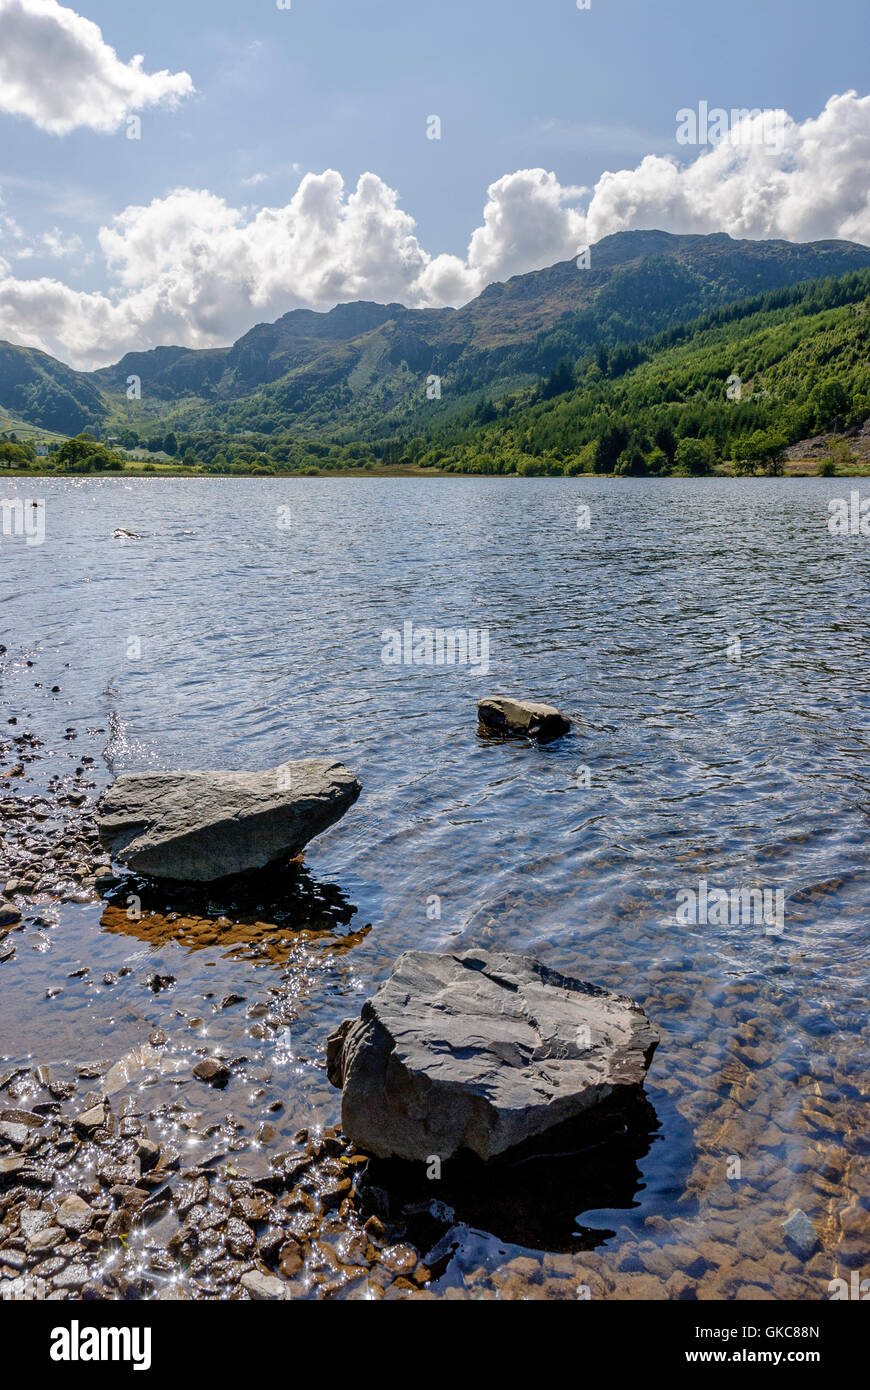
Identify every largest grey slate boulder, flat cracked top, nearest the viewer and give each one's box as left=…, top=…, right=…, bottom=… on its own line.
left=327, top=951, right=659, bottom=1161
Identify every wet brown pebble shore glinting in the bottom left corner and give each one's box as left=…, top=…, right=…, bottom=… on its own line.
left=0, top=1068, right=431, bottom=1300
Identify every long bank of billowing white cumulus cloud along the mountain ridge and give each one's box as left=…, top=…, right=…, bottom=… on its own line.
left=0, top=92, right=870, bottom=366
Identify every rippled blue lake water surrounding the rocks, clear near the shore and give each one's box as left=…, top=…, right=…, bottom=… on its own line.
left=0, top=478, right=870, bottom=1297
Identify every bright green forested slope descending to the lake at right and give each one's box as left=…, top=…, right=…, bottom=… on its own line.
left=414, top=271, right=870, bottom=474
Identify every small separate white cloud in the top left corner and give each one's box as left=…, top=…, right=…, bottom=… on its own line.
left=0, top=0, right=193, bottom=135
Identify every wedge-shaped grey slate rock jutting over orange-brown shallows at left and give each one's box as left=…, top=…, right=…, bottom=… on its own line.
left=97, top=758, right=360, bottom=883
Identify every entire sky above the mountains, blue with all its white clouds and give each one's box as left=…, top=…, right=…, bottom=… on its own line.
left=0, top=0, right=870, bottom=368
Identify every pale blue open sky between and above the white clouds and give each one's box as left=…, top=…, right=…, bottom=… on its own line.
left=0, top=0, right=870, bottom=364
